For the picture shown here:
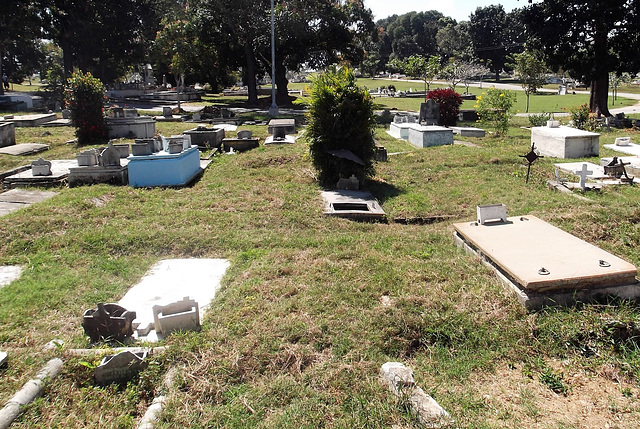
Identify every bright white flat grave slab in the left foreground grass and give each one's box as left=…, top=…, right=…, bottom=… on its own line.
left=119, top=259, right=230, bottom=341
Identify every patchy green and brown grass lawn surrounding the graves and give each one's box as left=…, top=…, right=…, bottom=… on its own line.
left=0, top=118, right=640, bottom=428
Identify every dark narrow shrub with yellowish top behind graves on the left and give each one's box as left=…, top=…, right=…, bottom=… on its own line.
left=64, top=72, right=107, bottom=145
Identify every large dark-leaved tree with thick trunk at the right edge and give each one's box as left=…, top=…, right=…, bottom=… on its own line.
left=524, top=0, right=640, bottom=116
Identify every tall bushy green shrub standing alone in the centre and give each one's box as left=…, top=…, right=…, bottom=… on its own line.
left=305, top=68, right=375, bottom=187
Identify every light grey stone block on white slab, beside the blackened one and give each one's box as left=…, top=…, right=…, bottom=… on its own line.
left=153, top=296, right=200, bottom=336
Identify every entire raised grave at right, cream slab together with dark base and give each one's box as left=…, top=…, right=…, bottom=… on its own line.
left=453, top=216, right=640, bottom=310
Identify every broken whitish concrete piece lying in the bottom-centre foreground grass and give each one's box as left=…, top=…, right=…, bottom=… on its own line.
left=380, top=362, right=451, bottom=428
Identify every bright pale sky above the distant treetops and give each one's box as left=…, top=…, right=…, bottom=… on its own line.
left=364, top=0, right=529, bottom=21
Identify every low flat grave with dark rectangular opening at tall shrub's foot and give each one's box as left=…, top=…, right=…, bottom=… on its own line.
left=321, top=190, right=386, bottom=220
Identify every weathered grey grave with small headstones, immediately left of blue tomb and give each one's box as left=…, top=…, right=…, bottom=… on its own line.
left=69, top=142, right=129, bottom=187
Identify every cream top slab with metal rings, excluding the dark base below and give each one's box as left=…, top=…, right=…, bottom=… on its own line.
left=453, top=216, right=637, bottom=292
